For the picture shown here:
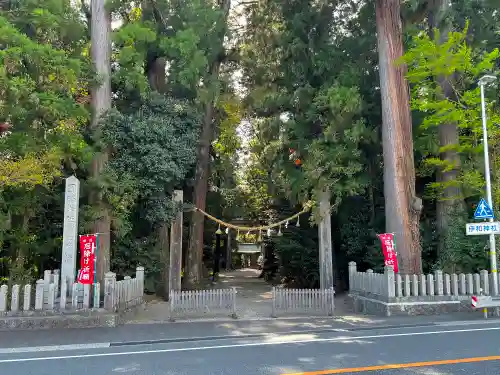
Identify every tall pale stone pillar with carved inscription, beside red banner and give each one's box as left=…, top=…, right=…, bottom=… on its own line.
left=61, top=176, right=80, bottom=293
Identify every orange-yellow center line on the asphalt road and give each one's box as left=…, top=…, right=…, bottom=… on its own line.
left=281, top=355, right=500, bottom=375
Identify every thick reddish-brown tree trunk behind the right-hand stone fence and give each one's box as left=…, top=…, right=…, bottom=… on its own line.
left=375, top=0, right=422, bottom=274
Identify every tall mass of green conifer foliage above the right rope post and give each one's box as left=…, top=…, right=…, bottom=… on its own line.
left=240, top=2, right=372, bottom=214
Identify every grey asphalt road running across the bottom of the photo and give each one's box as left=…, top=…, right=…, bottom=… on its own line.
left=0, top=322, right=500, bottom=375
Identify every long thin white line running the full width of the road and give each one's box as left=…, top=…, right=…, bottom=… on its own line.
left=0, top=327, right=500, bottom=363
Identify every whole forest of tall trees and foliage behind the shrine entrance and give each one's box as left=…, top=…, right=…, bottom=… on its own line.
left=0, top=0, right=500, bottom=294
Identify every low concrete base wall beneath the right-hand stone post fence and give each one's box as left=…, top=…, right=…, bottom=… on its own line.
left=349, top=293, right=474, bottom=316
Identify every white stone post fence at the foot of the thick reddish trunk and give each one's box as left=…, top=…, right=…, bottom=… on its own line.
left=349, top=262, right=492, bottom=298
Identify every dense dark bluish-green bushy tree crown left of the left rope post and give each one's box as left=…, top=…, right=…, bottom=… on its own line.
left=103, top=95, right=200, bottom=222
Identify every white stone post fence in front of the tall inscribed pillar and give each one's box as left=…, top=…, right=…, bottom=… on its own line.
left=0, top=267, right=144, bottom=316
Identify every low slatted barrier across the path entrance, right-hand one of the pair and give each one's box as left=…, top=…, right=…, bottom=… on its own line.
left=272, top=287, right=335, bottom=317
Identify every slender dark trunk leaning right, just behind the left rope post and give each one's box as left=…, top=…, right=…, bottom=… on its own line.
left=184, top=0, right=231, bottom=288
